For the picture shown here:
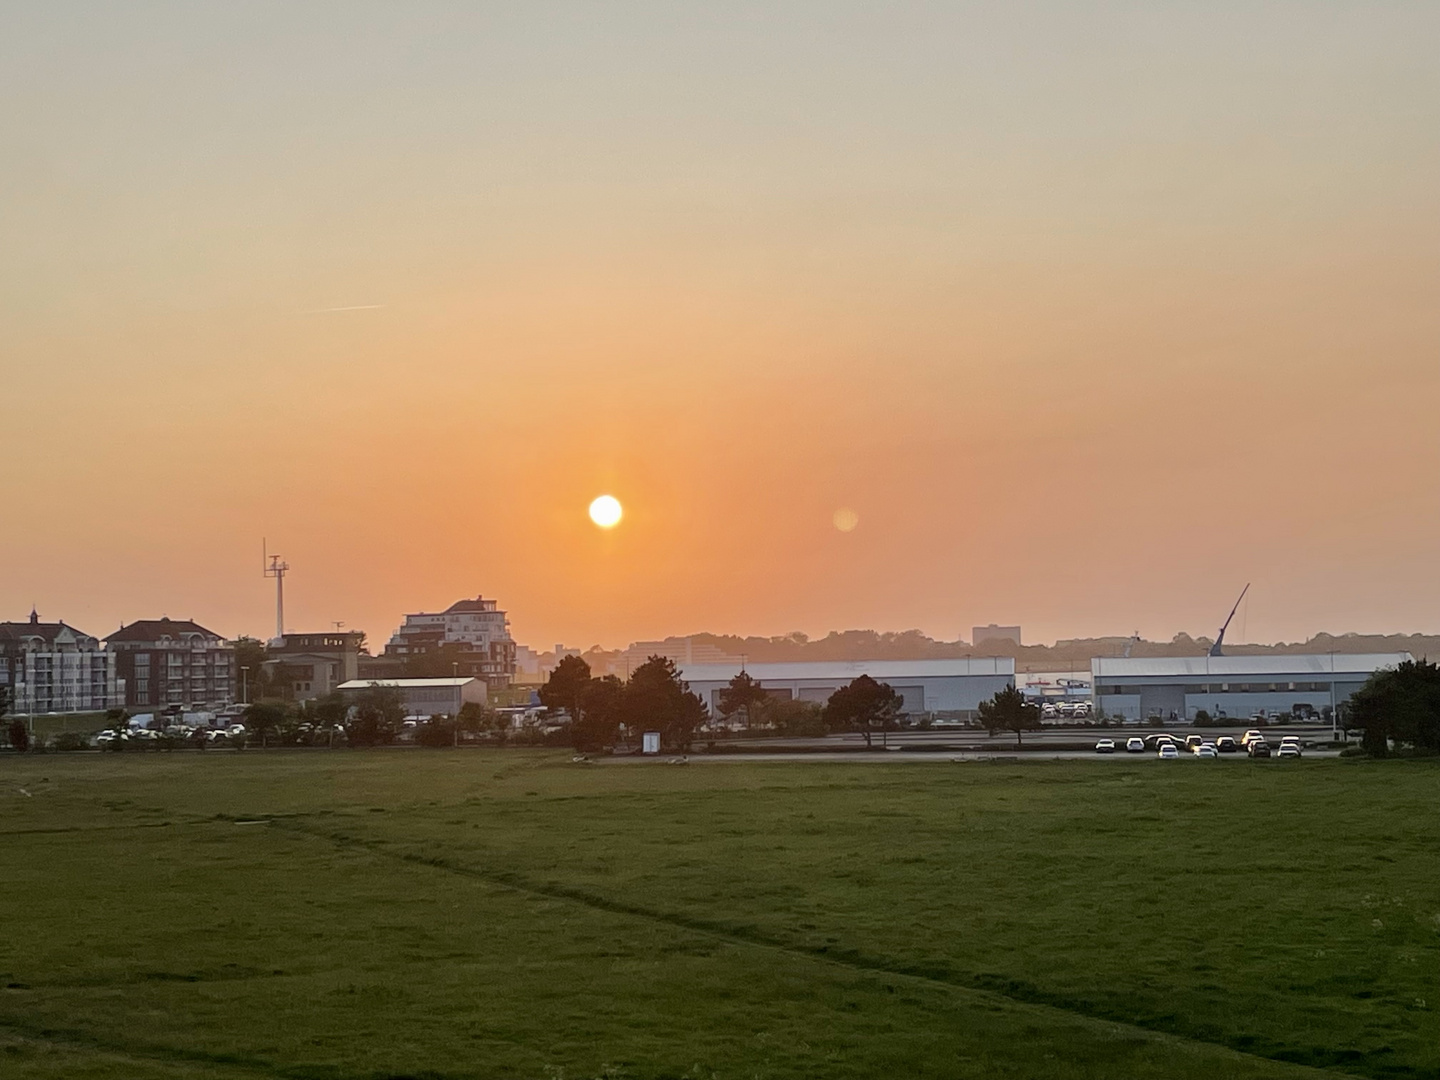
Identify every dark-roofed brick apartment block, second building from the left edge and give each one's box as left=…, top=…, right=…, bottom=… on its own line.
left=105, top=618, right=235, bottom=708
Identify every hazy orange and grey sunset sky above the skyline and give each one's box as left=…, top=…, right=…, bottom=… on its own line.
left=0, top=0, right=1440, bottom=648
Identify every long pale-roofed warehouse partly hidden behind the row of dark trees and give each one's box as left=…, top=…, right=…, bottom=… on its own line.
left=680, top=657, right=1015, bottom=717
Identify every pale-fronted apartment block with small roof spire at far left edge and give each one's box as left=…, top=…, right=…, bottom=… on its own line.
left=0, top=611, right=124, bottom=714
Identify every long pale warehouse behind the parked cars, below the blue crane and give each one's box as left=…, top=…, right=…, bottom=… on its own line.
left=1090, top=652, right=1411, bottom=721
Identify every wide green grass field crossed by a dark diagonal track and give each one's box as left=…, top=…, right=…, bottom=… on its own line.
left=0, top=750, right=1440, bottom=1080
